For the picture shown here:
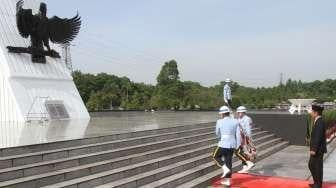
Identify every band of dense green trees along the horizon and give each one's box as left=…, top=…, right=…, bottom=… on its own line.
left=72, top=63, right=336, bottom=110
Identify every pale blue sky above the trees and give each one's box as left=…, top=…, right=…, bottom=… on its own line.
left=46, top=0, right=336, bottom=86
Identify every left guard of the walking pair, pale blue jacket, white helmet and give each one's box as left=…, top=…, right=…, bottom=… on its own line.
left=213, top=106, right=240, bottom=186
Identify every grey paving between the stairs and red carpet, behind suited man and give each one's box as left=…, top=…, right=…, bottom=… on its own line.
left=251, top=139, right=336, bottom=182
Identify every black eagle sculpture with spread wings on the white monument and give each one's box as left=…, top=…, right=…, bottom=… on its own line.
left=7, top=0, right=81, bottom=63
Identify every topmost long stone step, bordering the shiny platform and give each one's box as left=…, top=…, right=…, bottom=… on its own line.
left=0, top=123, right=215, bottom=157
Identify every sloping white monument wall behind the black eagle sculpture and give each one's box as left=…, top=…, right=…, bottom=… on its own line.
left=0, top=0, right=90, bottom=122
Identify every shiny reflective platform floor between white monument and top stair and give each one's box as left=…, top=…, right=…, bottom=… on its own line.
left=0, top=112, right=218, bottom=148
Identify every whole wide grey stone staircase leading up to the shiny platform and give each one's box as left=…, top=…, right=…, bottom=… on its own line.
left=0, top=123, right=288, bottom=188
